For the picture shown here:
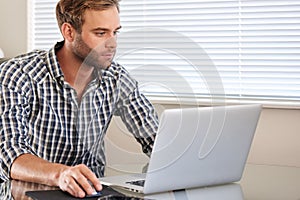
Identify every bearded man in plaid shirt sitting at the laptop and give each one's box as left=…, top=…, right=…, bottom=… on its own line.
left=0, top=0, right=158, bottom=197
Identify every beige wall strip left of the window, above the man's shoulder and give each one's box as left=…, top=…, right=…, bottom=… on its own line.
left=0, top=0, right=27, bottom=57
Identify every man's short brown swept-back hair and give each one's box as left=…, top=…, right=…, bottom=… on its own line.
left=56, top=0, right=120, bottom=33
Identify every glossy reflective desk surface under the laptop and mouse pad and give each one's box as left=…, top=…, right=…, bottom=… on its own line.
left=0, top=164, right=300, bottom=200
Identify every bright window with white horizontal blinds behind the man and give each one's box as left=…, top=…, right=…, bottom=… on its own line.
left=30, top=0, right=300, bottom=107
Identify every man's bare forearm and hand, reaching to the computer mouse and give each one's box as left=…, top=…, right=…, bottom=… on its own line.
left=10, top=154, right=102, bottom=198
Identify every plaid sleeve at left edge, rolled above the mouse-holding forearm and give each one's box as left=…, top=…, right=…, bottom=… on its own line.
left=0, top=61, right=32, bottom=181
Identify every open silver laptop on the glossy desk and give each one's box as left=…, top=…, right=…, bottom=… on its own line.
left=100, top=105, right=261, bottom=194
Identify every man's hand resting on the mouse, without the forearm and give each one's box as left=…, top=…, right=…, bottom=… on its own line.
left=59, top=165, right=102, bottom=198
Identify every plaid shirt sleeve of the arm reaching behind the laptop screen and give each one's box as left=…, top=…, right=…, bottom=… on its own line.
left=113, top=65, right=158, bottom=156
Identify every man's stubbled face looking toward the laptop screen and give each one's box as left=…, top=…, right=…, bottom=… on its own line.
left=73, top=7, right=121, bottom=69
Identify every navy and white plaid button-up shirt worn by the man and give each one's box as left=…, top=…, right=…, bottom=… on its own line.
left=0, top=43, right=158, bottom=180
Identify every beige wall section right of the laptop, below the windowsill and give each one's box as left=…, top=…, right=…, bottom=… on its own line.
left=249, top=109, right=300, bottom=167
